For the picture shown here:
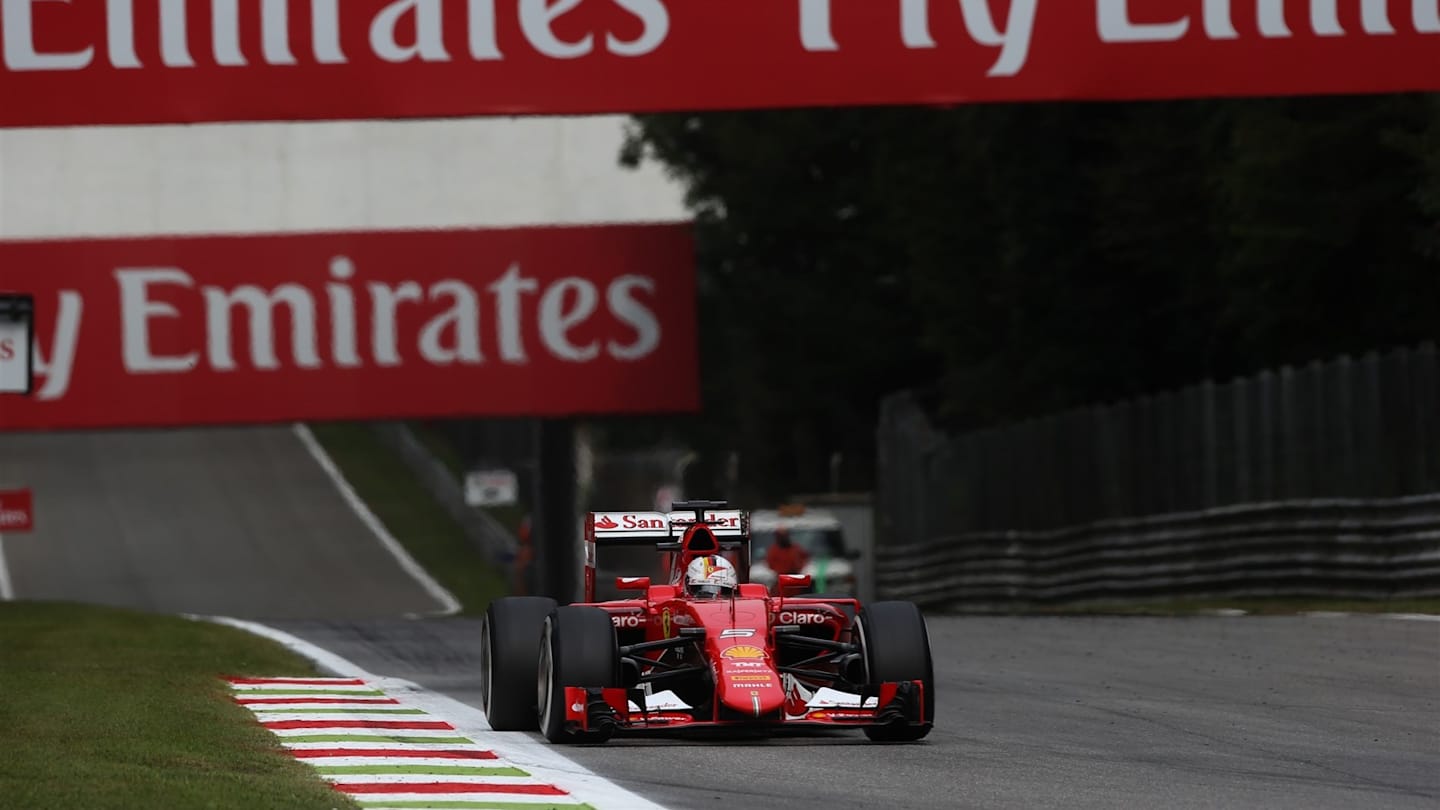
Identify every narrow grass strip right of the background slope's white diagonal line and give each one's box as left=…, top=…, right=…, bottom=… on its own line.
left=310, top=424, right=508, bottom=615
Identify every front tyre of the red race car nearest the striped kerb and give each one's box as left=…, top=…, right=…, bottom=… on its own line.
left=530, top=607, right=621, bottom=744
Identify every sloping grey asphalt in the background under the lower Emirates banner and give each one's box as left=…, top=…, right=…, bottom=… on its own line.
left=0, top=428, right=439, bottom=618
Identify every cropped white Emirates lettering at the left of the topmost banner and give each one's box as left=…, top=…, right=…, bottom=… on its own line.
left=0, top=0, right=670, bottom=71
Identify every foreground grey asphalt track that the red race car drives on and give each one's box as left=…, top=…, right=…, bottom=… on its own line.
left=279, top=615, right=1440, bottom=810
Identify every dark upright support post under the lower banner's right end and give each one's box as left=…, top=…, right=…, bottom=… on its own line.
left=531, top=419, right=580, bottom=604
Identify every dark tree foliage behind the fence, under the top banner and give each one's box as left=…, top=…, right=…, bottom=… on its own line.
left=622, top=95, right=1440, bottom=497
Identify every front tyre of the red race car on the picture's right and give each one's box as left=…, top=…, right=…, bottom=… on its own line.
left=855, top=602, right=935, bottom=742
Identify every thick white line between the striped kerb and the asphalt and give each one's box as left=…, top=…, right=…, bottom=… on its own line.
left=201, top=615, right=665, bottom=810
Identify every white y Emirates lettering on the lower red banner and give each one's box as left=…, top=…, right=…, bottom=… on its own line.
left=22, top=257, right=661, bottom=399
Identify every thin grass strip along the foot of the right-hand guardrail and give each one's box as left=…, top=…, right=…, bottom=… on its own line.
left=958, top=597, right=1440, bottom=615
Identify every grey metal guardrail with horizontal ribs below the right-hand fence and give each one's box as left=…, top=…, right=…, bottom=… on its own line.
left=876, top=484, right=1440, bottom=605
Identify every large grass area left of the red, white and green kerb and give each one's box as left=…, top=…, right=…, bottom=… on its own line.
left=0, top=602, right=357, bottom=810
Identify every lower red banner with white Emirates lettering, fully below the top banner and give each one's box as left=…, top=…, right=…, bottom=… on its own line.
left=0, top=223, right=700, bottom=431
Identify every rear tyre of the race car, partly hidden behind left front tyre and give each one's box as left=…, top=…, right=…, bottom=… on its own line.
left=480, top=597, right=556, bottom=731
